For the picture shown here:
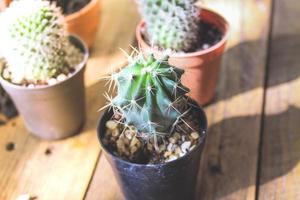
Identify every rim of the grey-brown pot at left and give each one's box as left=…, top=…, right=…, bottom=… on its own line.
left=0, top=35, right=89, bottom=91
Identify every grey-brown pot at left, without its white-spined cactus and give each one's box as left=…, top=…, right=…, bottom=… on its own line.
left=0, top=36, right=88, bottom=140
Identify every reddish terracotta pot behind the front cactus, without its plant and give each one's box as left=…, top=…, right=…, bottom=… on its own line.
left=136, top=8, right=229, bottom=105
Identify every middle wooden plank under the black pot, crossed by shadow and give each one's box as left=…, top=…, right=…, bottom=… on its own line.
left=86, top=0, right=271, bottom=200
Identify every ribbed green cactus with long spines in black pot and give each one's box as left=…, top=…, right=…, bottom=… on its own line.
left=98, top=53, right=207, bottom=200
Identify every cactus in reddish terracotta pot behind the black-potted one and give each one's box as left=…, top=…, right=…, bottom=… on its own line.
left=136, top=0, right=229, bottom=105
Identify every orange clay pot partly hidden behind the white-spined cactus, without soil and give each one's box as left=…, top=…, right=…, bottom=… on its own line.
left=0, top=0, right=100, bottom=48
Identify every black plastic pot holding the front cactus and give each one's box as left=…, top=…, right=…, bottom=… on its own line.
left=97, top=104, right=207, bottom=200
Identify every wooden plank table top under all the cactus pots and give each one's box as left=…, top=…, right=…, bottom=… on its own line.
left=0, top=0, right=300, bottom=200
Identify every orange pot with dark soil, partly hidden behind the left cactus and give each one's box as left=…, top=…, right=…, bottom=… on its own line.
left=0, top=0, right=100, bottom=48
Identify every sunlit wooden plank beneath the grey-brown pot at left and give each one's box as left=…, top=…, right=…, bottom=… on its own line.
left=0, top=0, right=139, bottom=200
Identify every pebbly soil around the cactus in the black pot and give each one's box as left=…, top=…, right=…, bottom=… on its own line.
left=102, top=97, right=204, bottom=164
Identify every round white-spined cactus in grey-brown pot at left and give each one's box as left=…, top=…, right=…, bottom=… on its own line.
left=0, top=0, right=88, bottom=139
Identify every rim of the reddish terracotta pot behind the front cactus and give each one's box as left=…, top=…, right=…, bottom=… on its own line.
left=136, top=7, right=229, bottom=58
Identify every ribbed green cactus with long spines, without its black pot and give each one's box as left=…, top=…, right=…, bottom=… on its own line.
left=104, top=54, right=189, bottom=141
